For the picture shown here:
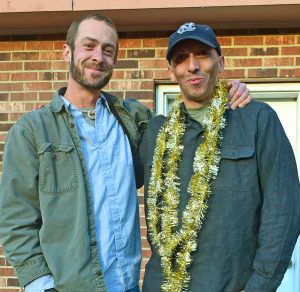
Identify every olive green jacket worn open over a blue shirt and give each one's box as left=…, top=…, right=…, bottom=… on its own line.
left=0, top=88, right=152, bottom=292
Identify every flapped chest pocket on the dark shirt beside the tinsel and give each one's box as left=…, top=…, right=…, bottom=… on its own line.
left=213, top=148, right=257, bottom=191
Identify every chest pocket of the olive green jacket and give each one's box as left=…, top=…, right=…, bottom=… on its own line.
left=38, top=143, right=78, bottom=195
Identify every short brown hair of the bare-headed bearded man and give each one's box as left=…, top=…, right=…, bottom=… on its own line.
left=66, top=12, right=119, bottom=56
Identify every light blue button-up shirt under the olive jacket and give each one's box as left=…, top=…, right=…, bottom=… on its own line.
left=26, top=95, right=141, bottom=292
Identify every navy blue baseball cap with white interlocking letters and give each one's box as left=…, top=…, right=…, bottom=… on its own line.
left=167, top=22, right=222, bottom=62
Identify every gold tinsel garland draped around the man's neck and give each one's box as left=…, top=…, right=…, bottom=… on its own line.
left=147, top=81, right=228, bottom=292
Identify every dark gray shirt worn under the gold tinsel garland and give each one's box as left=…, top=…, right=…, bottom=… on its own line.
left=140, top=102, right=300, bottom=292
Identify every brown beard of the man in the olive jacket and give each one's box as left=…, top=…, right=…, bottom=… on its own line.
left=70, top=52, right=113, bottom=90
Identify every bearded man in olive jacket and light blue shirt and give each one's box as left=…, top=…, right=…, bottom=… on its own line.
left=0, top=13, right=249, bottom=292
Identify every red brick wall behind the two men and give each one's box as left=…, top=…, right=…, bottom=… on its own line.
left=0, top=29, right=300, bottom=292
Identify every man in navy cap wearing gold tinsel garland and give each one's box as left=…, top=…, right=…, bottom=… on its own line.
left=140, top=23, right=300, bottom=292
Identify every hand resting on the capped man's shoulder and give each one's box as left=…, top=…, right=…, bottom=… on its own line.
left=227, top=80, right=252, bottom=110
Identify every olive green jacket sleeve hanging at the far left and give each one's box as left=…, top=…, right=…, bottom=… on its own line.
left=0, top=122, right=50, bottom=286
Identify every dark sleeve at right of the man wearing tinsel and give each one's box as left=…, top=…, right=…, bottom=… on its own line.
left=244, top=107, right=300, bottom=292
